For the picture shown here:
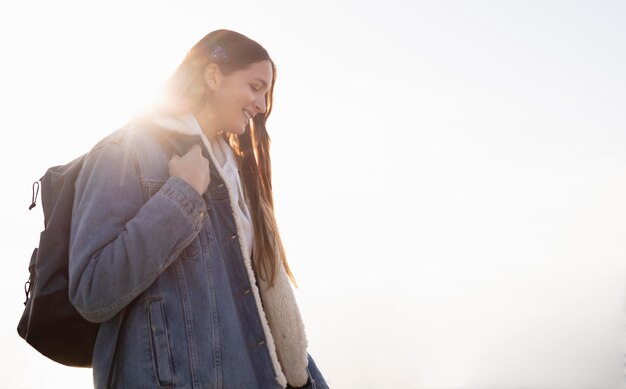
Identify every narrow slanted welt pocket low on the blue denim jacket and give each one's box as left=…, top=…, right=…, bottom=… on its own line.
left=148, top=298, right=173, bottom=386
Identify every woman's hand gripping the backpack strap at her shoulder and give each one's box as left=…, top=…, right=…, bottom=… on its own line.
left=168, top=144, right=211, bottom=195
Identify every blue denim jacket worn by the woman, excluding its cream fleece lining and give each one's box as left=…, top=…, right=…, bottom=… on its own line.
left=69, top=128, right=327, bottom=389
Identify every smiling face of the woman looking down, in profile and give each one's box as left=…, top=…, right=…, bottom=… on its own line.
left=210, top=60, right=273, bottom=135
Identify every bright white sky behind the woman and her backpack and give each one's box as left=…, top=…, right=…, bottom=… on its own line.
left=0, top=0, right=626, bottom=389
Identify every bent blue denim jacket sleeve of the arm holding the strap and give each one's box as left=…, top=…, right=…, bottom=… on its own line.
left=69, top=139, right=206, bottom=322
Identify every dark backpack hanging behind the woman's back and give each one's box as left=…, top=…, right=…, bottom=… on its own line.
left=17, top=155, right=99, bottom=367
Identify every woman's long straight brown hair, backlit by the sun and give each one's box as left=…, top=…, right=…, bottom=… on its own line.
left=145, top=30, right=297, bottom=286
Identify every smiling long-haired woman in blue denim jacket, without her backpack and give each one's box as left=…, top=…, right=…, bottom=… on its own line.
left=70, top=30, right=327, bottom=389
